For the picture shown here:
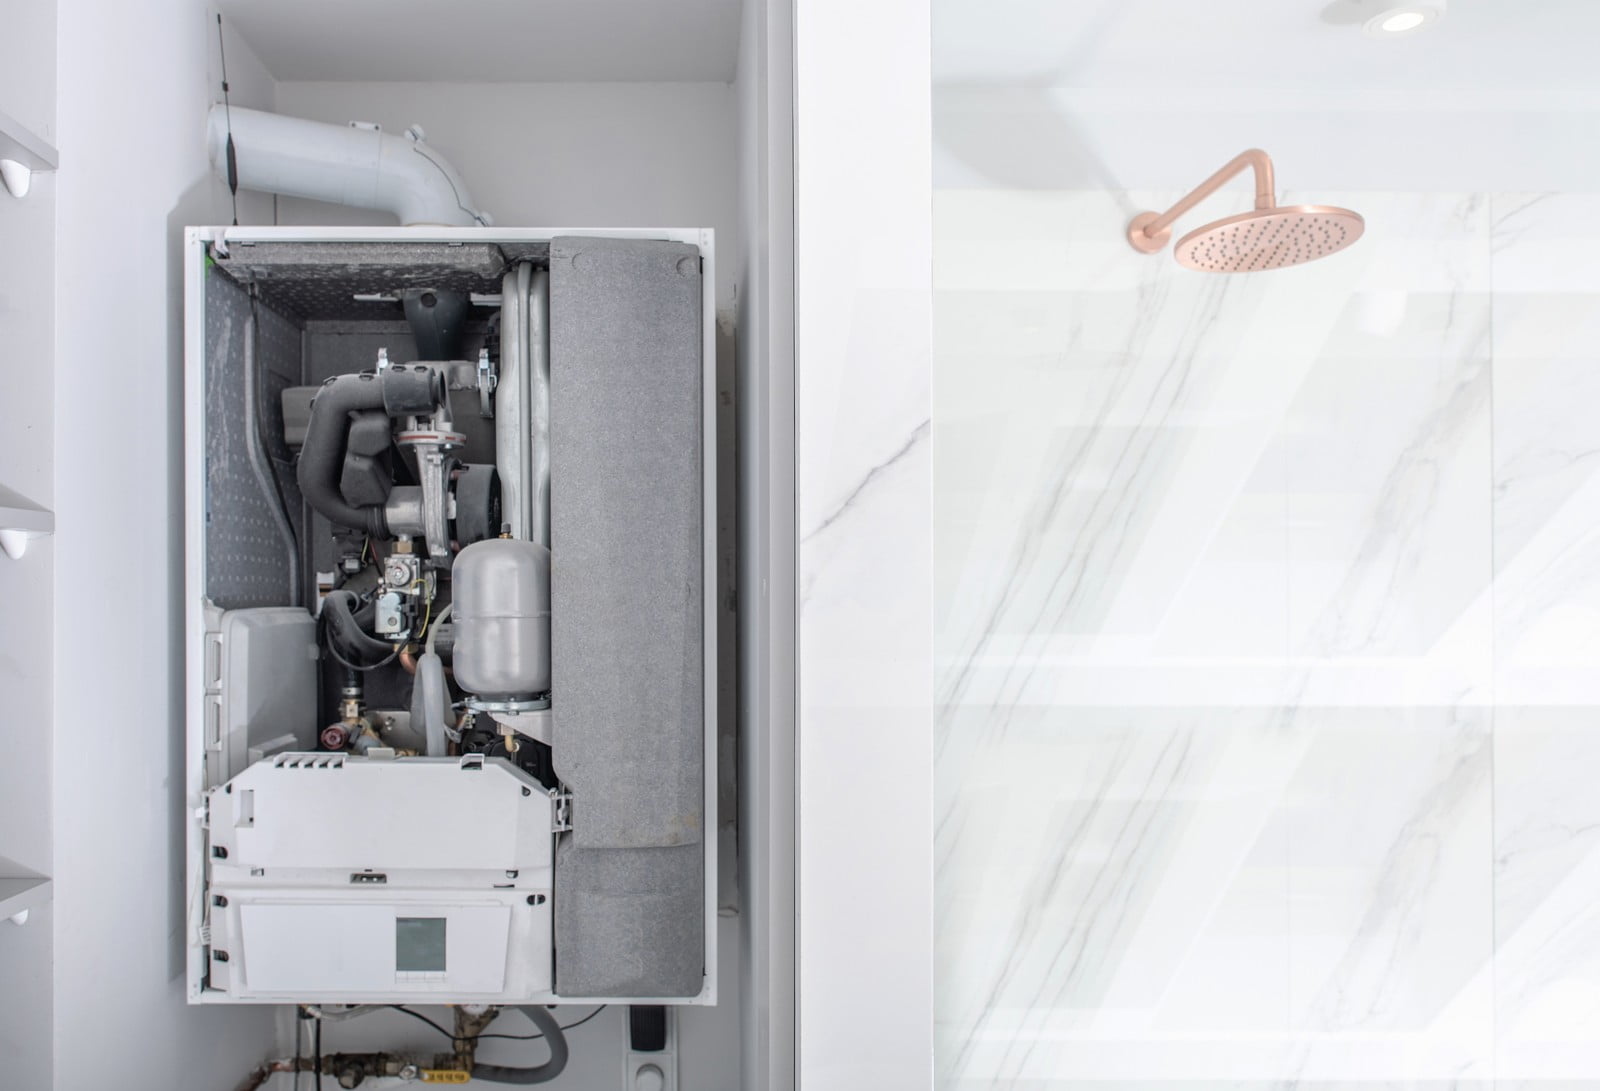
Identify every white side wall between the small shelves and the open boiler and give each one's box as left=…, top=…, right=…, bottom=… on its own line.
left=51, top=0, right=274, bottom=1091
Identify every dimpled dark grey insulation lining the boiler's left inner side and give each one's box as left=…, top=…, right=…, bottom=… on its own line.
left=205, top=269, right=306, bottom=609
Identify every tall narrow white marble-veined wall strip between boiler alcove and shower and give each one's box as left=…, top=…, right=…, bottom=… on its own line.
left=795, top=0, right=933, bottom=1091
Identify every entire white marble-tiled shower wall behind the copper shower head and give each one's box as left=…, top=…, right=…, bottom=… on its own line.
left=931, top=190, right=1600, bottom=1091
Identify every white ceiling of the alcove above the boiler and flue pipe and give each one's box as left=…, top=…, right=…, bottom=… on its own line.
left=218, top=0, right=741, bottom=82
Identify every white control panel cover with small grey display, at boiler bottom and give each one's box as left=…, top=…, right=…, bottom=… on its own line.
left=208, top=753, right=555, bottom=1003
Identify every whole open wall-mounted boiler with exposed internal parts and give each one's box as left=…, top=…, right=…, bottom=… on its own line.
left=186, top=227, right=717, bottom=1005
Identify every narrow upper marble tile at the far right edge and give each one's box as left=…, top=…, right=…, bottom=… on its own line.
left=1493, top=195, right=1600, bottom=705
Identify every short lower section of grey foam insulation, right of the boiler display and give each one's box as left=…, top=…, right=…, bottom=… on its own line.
left=555, top=837, right=706, bottom=998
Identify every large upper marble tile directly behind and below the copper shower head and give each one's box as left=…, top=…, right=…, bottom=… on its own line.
left=934, top=192, right=1490, bottom=705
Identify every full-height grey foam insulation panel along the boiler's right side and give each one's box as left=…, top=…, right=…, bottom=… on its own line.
left=550, top=238, right=706, bottom=998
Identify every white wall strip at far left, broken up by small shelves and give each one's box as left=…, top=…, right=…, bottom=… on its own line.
left=0, top=0, right=56, bottom=1088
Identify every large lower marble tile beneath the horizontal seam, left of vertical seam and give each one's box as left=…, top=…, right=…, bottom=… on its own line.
left=934, top=709, right=1491, bottom=1089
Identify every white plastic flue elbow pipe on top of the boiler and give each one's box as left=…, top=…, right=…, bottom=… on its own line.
left=206, top=104, right=491, bottom=227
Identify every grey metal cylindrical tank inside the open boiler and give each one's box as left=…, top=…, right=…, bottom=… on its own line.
left=451, top=538, right=550, bottom=701
